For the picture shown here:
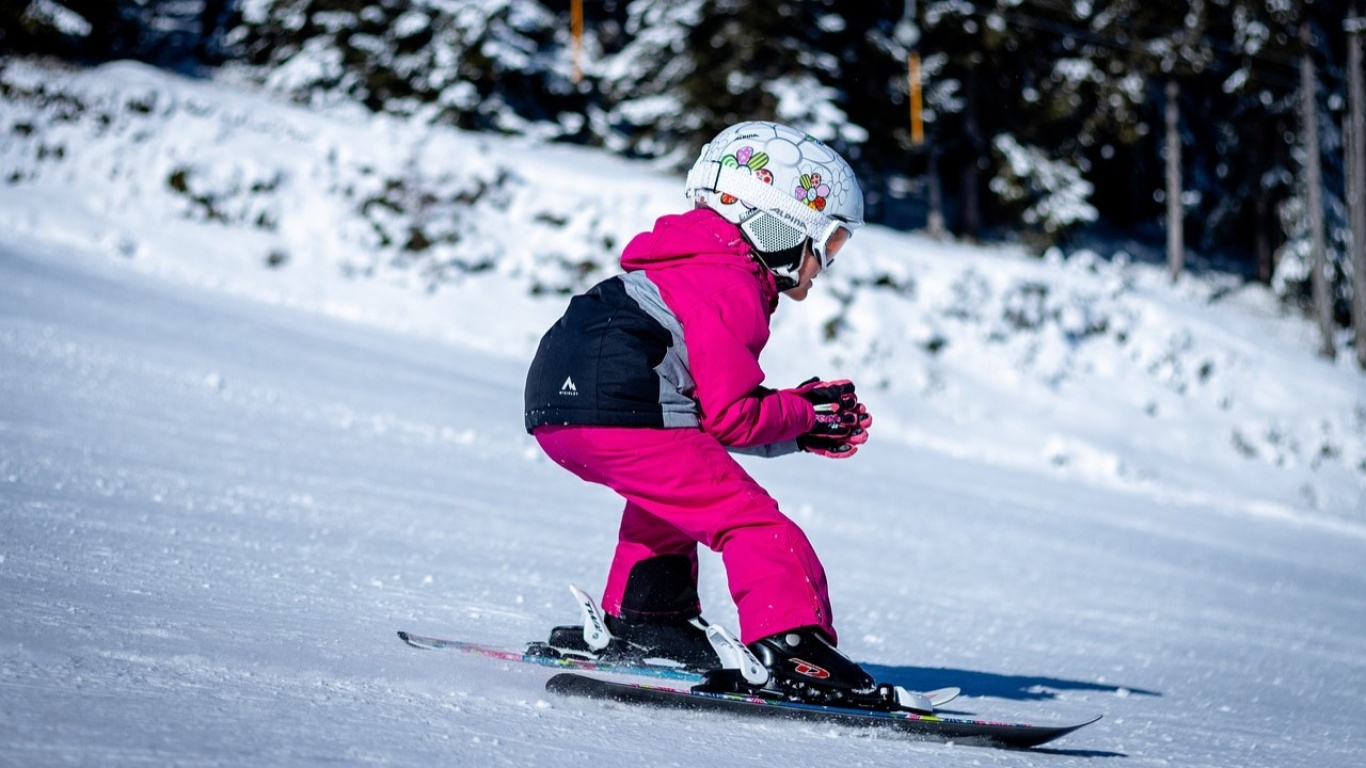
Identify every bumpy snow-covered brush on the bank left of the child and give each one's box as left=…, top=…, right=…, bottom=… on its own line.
left=0, top=61, right=661, bottom=292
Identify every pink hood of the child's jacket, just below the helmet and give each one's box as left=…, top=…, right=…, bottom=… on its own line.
left=622, top=208, right=777, bottom=312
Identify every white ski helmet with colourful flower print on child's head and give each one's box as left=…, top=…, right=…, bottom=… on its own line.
left=684, top=122, right=863, bottom=290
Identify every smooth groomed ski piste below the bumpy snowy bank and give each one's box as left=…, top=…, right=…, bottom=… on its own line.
left=0, top=245, right=1366, bottom=768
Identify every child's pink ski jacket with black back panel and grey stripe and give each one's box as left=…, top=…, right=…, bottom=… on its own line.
left=526, top=209, right=816, bottom=454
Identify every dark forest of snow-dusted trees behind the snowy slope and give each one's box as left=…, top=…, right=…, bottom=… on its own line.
left=0, top=0, right=1366, bottom=366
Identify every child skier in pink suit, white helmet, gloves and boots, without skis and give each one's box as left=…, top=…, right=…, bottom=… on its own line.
left=526, top=122, right=876, bottom=696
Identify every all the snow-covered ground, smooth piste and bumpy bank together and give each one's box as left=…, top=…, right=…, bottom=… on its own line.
left=0, top=60, right=1366, bottom=768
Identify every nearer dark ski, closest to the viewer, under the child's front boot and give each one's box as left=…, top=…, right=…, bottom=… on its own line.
left=545, top=672, right=1100, bottom=749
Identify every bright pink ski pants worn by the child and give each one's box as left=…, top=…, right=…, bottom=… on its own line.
left=535, top=426, right=837, bottom=644
